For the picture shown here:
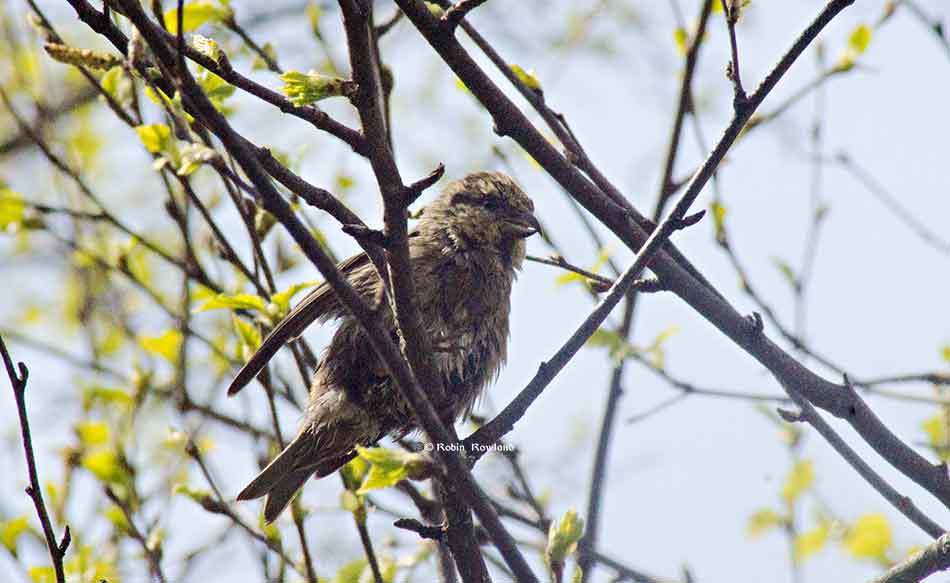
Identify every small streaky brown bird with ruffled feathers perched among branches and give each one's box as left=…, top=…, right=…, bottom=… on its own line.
left=228, top=172, right=540, bottom=522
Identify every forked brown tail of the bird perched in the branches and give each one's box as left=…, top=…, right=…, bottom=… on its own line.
left=237, top=428, right=364, bottom=524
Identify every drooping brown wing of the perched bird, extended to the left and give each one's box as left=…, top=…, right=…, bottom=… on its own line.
left=228, top=253, right=372, bottom=395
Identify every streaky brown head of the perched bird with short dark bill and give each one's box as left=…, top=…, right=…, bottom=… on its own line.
left=420, top=172, right=541, bottom=263
